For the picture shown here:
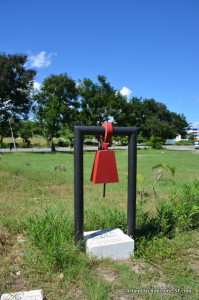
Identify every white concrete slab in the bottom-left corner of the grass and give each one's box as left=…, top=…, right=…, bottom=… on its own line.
left=1, top=290, right=43, bottom=300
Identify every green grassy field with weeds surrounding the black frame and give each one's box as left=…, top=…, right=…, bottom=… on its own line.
left=0, top=149, right=199, bottom=300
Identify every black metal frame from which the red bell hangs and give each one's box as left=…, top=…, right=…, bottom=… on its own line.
left=74, top=126, right=137, bottom=244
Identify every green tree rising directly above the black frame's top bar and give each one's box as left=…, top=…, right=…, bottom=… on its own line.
left=78, top=75, right=127, bottom=125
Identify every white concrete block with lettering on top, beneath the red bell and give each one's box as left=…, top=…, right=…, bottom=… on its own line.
left=84, top=228, right=134, bottom=260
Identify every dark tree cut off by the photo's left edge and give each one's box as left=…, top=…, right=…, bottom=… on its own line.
left=0, top=54, right=36, bottom=138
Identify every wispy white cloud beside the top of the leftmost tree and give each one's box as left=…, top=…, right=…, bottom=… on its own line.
left=28, top=51, right=57, bottom=68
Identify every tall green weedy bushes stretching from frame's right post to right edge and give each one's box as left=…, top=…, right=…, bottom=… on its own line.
left=137, top=180, right=199, bottom=241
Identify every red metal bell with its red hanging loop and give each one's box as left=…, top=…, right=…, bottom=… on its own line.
left=91, top=122, right=119, bottom=183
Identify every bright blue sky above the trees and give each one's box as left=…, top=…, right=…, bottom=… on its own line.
left=0, top=0, right=199, bottom=127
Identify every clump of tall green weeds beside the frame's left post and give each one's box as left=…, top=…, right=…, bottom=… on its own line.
left=26, top=208, right=88, bottom=270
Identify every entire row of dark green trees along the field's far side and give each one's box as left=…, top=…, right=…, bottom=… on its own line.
left=0, top=54, right=188, bottom=146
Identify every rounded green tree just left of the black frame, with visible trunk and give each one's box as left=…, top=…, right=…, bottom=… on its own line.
left=34, top=74, right=79, bottom=151
